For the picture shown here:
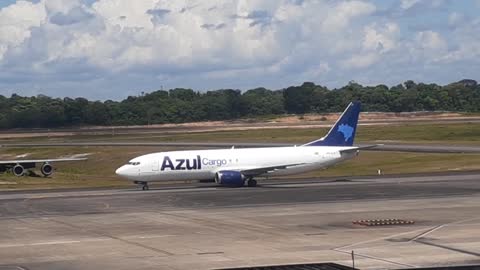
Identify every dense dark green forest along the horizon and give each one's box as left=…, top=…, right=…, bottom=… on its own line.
left=0, top=80, right=480, bottom=129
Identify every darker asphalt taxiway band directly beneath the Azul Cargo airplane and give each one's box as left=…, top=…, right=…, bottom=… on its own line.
left=0, top=174, right=480, bottom=218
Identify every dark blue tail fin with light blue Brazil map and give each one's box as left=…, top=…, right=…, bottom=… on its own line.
left=303, top=101, right=360, bottom=146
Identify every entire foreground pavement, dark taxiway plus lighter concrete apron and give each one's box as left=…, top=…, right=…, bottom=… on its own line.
left=0, top=173, right=480, bottom=270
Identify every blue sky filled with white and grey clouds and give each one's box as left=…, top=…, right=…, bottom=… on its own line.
left=0, top=0, right=480, bottom=100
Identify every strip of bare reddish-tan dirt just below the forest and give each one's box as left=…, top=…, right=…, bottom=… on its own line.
left=0, top=112, right=480, bottom=140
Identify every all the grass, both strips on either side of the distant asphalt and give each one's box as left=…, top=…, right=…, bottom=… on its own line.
left=0, top=123, right=480, bottom=189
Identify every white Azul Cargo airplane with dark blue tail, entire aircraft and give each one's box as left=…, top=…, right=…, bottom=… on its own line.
left=115, top=101, right=376, bottom=190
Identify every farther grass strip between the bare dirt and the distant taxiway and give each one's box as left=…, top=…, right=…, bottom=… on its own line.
left=59, top=123, right=480, bottom=145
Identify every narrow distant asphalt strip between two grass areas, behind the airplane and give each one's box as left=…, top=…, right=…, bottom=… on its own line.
left=0, top=142, right=480, bottom=153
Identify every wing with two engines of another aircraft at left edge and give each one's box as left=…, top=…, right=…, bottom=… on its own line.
left=0, top=158, right=87, bottom=177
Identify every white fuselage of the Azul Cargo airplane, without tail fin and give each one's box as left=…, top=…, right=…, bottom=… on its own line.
left=116, top=146, right=356, bottom=182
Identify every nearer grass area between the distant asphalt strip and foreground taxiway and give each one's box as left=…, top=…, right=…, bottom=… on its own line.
left=0, top=147, right=480, bottom=189
